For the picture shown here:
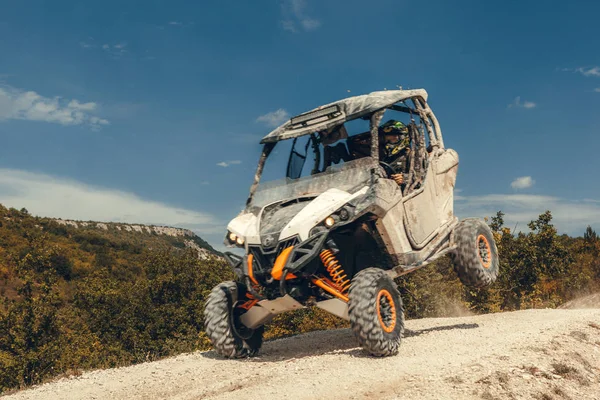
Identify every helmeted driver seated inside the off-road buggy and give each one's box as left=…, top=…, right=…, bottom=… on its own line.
left=379, top=119, right=410, bottom=185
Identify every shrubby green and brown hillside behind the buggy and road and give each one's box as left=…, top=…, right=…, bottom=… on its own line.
left=0, top=205, right=600, bottom=393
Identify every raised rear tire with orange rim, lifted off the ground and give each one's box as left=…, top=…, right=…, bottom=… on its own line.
left=452, top=218, right=499, bottom=288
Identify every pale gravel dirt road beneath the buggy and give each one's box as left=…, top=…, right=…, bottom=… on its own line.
left=5, top=308, right=600, bottom=400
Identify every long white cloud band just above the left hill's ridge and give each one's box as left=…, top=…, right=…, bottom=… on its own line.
left=0, top=169, right=224, bottom=233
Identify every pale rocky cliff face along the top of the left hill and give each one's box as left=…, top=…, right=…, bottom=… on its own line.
left=53, top=218, right=221, bottom=259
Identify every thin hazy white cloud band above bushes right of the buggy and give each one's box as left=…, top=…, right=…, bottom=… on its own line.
left=455, top=194, right=600, bottom=236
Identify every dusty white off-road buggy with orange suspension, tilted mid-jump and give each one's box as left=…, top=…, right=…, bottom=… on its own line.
left=204, top=89, right=498, bottom=357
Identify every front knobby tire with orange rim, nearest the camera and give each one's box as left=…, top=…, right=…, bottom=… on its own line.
left=348, top=268, right=404, bottom=357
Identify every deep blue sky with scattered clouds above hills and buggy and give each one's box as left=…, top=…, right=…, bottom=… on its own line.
left=0, top=0, right=600, bottom=247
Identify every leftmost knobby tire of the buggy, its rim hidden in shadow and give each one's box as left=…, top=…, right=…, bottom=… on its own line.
left=204, top=281, right=264, bottom=358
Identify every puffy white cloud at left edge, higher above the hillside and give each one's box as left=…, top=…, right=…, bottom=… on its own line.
left=0, top=86, right=109, bottom=128
